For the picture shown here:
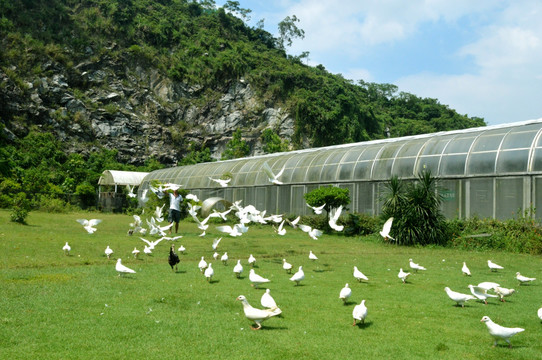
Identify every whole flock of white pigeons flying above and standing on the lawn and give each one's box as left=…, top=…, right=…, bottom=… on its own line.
left=63, top=163, right=542, bottom=346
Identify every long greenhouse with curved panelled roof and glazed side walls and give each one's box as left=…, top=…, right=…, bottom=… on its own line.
left=140, top=119, right=542, bottom=219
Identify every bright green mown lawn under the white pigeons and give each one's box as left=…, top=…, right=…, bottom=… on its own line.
left=0, top=211, right=542, bottom=360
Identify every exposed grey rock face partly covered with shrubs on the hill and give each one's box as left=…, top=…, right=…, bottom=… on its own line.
left=0, top=53, right=294, bottom=165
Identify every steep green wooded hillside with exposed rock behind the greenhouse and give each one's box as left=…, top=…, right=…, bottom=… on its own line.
left=0, top=0, right=485, bottom=207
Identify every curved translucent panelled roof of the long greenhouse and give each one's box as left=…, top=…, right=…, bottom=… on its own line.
left=145, top=119, right=542, bottom=189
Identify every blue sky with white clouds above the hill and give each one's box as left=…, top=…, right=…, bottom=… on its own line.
left=216, top=0, right=542, bottom=125
